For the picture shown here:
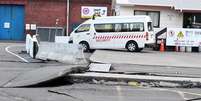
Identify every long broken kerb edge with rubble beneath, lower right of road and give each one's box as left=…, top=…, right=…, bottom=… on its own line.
left=69, top=72, right=201, bottom=88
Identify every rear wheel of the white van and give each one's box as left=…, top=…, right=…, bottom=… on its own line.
left=126, top=41, right=139, bottom=52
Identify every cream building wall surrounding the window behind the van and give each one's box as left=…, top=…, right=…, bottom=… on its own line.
left=119, top=6, right=183, bottom=35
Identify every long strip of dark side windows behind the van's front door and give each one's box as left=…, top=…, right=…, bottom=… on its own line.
left=94, top=22, right=144, bottom=32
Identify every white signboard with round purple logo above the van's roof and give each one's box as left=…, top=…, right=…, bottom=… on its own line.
left=81, top=6, right=107, bottom=18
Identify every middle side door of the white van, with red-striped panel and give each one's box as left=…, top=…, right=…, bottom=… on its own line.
left=92, top=24, right=114, bottom=49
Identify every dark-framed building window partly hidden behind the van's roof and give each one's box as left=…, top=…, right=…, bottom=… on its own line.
left=134, top=10, right=160, bottom=28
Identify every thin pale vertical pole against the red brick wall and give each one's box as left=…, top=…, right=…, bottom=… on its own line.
left=66, top=0, right=70, bottom=36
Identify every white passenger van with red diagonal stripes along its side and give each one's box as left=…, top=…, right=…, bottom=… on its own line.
left=69, top=16, right=155, bottom=52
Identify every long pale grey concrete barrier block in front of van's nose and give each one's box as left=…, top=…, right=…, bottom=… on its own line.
left=36, top=42, right=87, bottom=64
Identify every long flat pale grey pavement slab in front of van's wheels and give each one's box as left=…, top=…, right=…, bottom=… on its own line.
left=90, top=50, right=201, bottom=68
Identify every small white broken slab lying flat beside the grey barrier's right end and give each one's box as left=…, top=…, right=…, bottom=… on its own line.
left=89, top=63, right=111, bottom=72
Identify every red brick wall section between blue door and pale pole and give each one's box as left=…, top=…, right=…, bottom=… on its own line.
left=25, top=0, right=67, bottom=27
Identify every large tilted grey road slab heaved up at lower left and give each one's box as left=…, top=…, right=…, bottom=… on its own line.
left=3, top=65, right=86, bottom=87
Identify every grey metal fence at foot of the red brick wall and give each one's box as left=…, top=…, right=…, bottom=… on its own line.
left=36, top=27, right=64, bottom=42
